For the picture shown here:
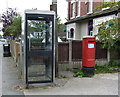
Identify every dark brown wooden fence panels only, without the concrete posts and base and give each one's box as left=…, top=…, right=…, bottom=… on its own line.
left=58, top=40, right=107, bottom=62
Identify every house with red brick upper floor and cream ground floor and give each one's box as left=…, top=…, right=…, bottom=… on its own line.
left=65, top=0, right=118, bottom=40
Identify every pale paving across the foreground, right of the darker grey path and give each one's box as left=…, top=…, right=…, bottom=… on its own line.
left=24, top=73, right=118, bottom=95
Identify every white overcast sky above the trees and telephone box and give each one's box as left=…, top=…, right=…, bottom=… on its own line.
left=0, top=0, right=67, bottom=23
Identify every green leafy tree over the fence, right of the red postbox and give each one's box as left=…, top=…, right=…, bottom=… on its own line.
left=96, top=18, right=120, bottom=62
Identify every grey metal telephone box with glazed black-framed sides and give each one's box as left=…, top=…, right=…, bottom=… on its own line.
left=21, top=10, right=56, bottom=86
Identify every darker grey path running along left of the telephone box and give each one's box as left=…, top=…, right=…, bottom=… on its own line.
left=0, top=44, right=23, bottom=95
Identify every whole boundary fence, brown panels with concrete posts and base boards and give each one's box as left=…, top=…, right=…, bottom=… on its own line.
left=10, top=40, right=118, bottom=70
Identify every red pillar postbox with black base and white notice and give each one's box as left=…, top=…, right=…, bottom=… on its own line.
left=82, top=36, right=96, bottom=74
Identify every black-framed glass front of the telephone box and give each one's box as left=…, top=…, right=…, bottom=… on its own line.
left=26, top=13, right=54, bottom=81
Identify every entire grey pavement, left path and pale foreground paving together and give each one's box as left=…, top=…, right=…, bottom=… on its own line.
left=0, top=44, right=118, bottom=95
